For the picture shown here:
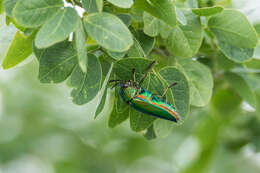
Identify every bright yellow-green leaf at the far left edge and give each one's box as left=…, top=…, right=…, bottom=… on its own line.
left=2, top=31, right=35, bottom=69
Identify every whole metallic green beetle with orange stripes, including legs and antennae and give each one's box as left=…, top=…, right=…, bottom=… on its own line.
left=109, top=61, right=180, bottom=122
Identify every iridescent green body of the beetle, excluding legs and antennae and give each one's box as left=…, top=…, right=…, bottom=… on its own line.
left=120, top=85, right=180, bottom=122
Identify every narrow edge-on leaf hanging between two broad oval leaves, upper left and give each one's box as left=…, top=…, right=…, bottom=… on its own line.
left=75, top=20, right=88, bottom=72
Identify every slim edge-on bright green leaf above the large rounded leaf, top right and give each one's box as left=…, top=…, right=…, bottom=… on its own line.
left=192, top=6, right=224, bottom=16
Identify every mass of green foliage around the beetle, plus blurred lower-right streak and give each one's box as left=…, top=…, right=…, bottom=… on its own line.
left=0, top=0, right=260, bottom=168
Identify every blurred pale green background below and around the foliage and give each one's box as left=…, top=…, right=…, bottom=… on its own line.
left=0, top=0, right=260, bottom=173
